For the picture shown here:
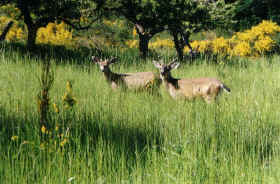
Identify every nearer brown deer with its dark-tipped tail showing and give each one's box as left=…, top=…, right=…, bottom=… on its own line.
left=153, top=61, right=230, bottom=103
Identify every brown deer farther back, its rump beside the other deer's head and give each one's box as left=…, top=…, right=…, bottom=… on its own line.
left=92, top=56, right=161, bottom=90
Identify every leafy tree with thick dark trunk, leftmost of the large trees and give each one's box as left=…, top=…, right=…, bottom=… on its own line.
left=0, top=0, right=101, bottom=47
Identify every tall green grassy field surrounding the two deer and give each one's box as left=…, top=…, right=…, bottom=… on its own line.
left=0, top=43, right=280, bottom=184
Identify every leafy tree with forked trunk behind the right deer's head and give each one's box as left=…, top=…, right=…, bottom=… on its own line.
left=158, top=0, right=210, bottom=60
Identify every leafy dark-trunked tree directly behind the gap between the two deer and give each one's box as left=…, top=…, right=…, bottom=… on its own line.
left=99, top=0, right=165, bottom=58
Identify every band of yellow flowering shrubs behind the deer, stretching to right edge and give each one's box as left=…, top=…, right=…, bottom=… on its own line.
left=126, top=20, right=280, bottom=57
